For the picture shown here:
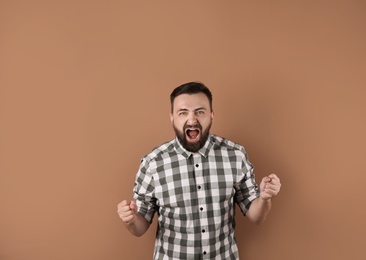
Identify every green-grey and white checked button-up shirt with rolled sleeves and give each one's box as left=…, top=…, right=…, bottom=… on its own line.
left=133, top=135, right=259, bottom=260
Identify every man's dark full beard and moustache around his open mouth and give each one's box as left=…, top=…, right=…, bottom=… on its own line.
left=173, top=122, right=212, bottom=153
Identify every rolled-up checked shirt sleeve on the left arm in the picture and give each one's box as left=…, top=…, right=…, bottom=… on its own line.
left=133, top=158, right=157, bottom=223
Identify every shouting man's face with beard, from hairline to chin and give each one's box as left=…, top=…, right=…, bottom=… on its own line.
left=170, top=93, right=214, bottom=152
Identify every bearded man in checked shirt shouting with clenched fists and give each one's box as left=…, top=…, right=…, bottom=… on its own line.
left=118, top=82, right=281, bottom=260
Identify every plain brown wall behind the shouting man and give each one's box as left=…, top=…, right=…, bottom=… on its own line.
left=0, top=0, right=366, bottom=260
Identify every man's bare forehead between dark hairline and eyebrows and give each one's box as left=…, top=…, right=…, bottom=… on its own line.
left=173, top=93, right=210, bottom=111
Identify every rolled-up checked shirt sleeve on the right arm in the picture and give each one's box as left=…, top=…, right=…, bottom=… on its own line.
left=234, top=150, right=260, bottom=215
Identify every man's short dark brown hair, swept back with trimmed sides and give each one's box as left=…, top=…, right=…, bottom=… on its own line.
left=170, top=81, right=212, bottom=113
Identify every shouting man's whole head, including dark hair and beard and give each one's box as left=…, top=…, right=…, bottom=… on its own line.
left=170, top=82, right=214, bottom=152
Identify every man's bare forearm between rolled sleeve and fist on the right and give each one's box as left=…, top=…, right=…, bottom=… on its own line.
left=245, top=197, right=272, bottom=225
